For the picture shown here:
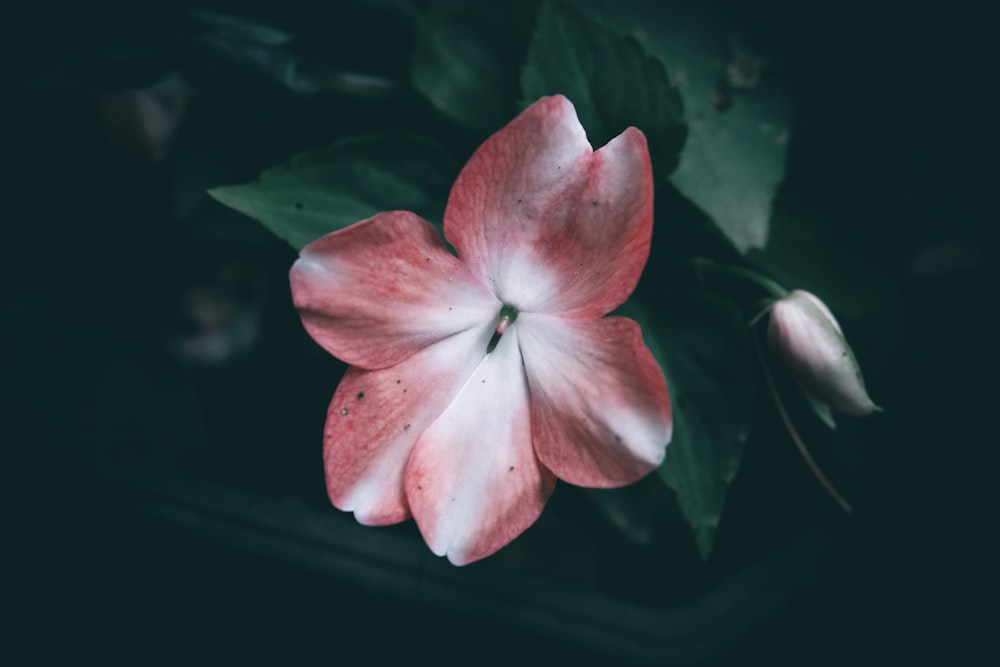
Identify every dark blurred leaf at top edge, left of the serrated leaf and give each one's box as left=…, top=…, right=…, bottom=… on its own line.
left=410, top=0, right=537, bottom=132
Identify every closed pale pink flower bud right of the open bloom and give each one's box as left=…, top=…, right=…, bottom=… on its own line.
left=767, top=290, right=879, bottom=417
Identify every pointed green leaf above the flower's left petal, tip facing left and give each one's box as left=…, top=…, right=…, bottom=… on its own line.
left=208, top=134, right=458, bottom=250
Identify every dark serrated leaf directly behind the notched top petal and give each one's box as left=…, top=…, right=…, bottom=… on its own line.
left=521, top=2, right=687, bottom=180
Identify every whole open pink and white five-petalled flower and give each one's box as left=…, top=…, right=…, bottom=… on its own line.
left=291, top=96, right=672, bottom=565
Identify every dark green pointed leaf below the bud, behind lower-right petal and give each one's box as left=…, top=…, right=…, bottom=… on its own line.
left=621, top=285, right=753, bottom=558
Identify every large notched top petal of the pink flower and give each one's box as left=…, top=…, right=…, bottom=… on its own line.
left=444, top=96, right=653, bottom=317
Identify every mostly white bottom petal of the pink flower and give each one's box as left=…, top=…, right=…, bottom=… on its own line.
left=406, top=331, right=555, bottom=565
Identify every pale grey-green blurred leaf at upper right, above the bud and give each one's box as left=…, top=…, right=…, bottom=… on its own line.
left=581, top=0, right=791, bottom=252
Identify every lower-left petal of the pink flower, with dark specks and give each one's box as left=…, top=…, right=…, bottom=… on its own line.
left=323, top=326, right=493, bottom=525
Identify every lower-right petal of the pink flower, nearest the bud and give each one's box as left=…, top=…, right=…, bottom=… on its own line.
left=516, top=314, right=673, bottom=487
